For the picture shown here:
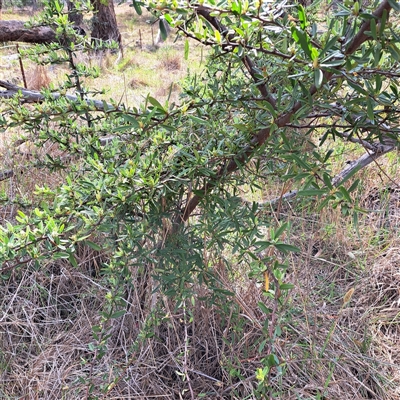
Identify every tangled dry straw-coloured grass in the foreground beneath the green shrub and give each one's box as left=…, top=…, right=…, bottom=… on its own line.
left=0, top=170, right=400, bottom=400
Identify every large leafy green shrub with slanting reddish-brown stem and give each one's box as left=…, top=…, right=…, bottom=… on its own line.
left=0, top=0, right=400, bottom=396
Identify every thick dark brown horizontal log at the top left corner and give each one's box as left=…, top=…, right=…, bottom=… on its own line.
left=0, top=21, right=56, bottom=44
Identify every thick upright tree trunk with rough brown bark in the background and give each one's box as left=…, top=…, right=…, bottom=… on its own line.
left=92, top=0, right=121, bottom=47
